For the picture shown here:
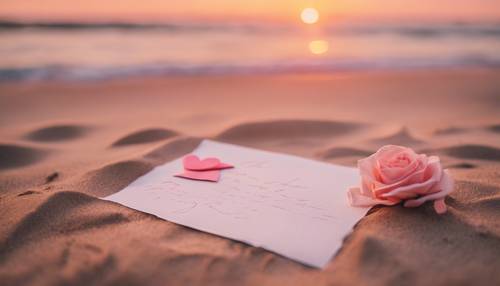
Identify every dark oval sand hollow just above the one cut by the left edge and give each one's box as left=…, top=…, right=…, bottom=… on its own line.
left=24, top=125, right=89, bottom=142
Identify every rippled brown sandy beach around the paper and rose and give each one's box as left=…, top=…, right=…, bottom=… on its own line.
left=0, top=69, right=500, bottom=285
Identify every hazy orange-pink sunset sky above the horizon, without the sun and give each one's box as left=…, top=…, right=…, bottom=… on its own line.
left=0, top=0, right=500, bottom=21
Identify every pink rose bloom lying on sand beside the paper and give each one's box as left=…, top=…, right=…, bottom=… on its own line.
left=348, top=145, right=453, bottom=214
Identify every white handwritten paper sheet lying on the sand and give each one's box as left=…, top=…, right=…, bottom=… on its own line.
left=104, top=140, right=367, bottom=267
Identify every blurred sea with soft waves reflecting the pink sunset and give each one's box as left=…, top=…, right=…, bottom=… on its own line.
left=0, top=21, right=500, bottom=81
